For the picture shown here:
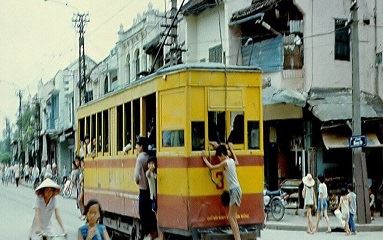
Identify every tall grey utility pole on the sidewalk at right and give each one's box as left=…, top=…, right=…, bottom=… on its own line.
left=350, top=0, right=371, bottom=223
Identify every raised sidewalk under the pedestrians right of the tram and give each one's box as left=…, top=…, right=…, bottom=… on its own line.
left=266, top=212, right=383, bottom=232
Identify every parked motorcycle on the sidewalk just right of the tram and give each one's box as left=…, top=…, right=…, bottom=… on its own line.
left=263, top=189, right=288, bottom=221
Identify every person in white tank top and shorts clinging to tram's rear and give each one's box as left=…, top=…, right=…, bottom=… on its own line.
left=202, top=143, right=242, bottom=240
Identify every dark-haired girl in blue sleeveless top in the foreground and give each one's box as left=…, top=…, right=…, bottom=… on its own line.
left=78, top=199, right=110, bottom=240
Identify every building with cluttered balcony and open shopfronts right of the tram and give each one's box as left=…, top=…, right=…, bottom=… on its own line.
left=230, top=0, right=383, bottom=193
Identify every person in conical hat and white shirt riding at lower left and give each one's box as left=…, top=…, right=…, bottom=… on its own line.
left=29, top=178, right=65, bottom=239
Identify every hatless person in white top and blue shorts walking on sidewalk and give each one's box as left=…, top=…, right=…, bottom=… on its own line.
left=315, top=175, right=331, bottom=233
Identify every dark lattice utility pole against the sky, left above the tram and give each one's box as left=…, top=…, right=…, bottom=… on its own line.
left=72, top=13, right=89, bottom=106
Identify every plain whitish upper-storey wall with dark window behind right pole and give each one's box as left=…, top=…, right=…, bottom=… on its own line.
left=295, top=0, right=383, bottom=93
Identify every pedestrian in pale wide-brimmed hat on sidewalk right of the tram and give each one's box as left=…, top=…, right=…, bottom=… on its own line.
left=302, top=173, right=315, bottom=234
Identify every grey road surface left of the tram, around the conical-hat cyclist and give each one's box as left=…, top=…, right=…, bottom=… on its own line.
left=0, top=183, right=83, bottom=240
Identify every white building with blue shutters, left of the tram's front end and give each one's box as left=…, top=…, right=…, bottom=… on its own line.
left=36, top=57, right=96, bottom=176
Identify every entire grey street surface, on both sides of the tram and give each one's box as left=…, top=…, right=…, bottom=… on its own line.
left=0, top=184, right=383, bottom=240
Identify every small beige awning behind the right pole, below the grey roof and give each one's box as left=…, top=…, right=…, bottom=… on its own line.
left=322, top=131, right=383, bottom=149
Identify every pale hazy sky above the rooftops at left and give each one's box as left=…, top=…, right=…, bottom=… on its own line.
left=0, top=0, right=172, bottom=137
